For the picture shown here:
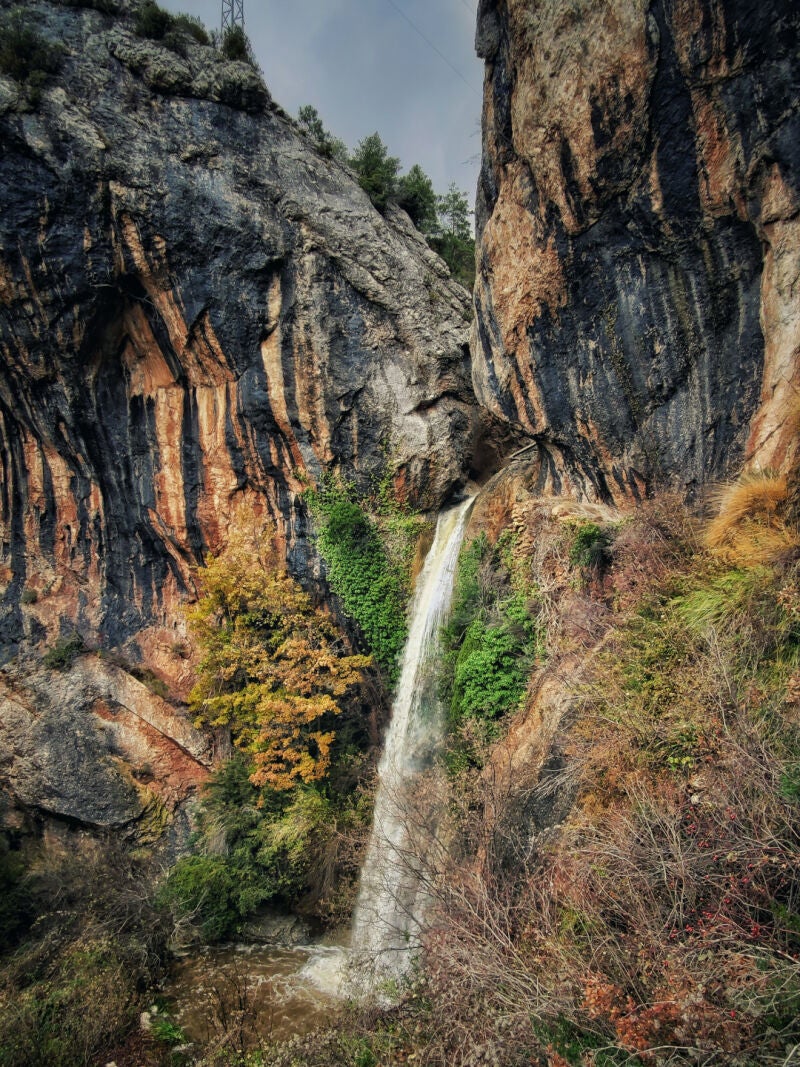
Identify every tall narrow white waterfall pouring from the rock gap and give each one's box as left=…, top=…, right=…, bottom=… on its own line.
left=351, top=499, right=473, bottom=977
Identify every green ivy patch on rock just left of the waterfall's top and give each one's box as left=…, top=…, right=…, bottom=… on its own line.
left=306, top=481, right=422, bottom=684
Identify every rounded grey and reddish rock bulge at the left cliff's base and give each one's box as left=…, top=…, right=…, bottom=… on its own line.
left=0, top=656, right=211, bottom=830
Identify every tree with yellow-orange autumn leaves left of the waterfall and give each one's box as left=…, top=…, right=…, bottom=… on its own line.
left=189, top=516, right=372, bottom=792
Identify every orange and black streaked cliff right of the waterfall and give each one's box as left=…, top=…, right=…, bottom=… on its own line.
left=473, top=0, right=800, bottom=501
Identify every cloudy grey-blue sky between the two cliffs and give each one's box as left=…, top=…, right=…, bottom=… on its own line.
left=156, top=0, right=483, bottom=205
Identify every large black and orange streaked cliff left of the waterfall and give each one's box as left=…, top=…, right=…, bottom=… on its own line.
left=0, top=2, right=473, bottom=824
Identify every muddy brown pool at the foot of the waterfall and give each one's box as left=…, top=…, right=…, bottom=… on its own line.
left=163, top=944, right=345, bottom=1048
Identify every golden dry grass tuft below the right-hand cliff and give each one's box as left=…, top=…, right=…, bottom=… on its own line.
left=705, top=472, right=800, bottom=567
